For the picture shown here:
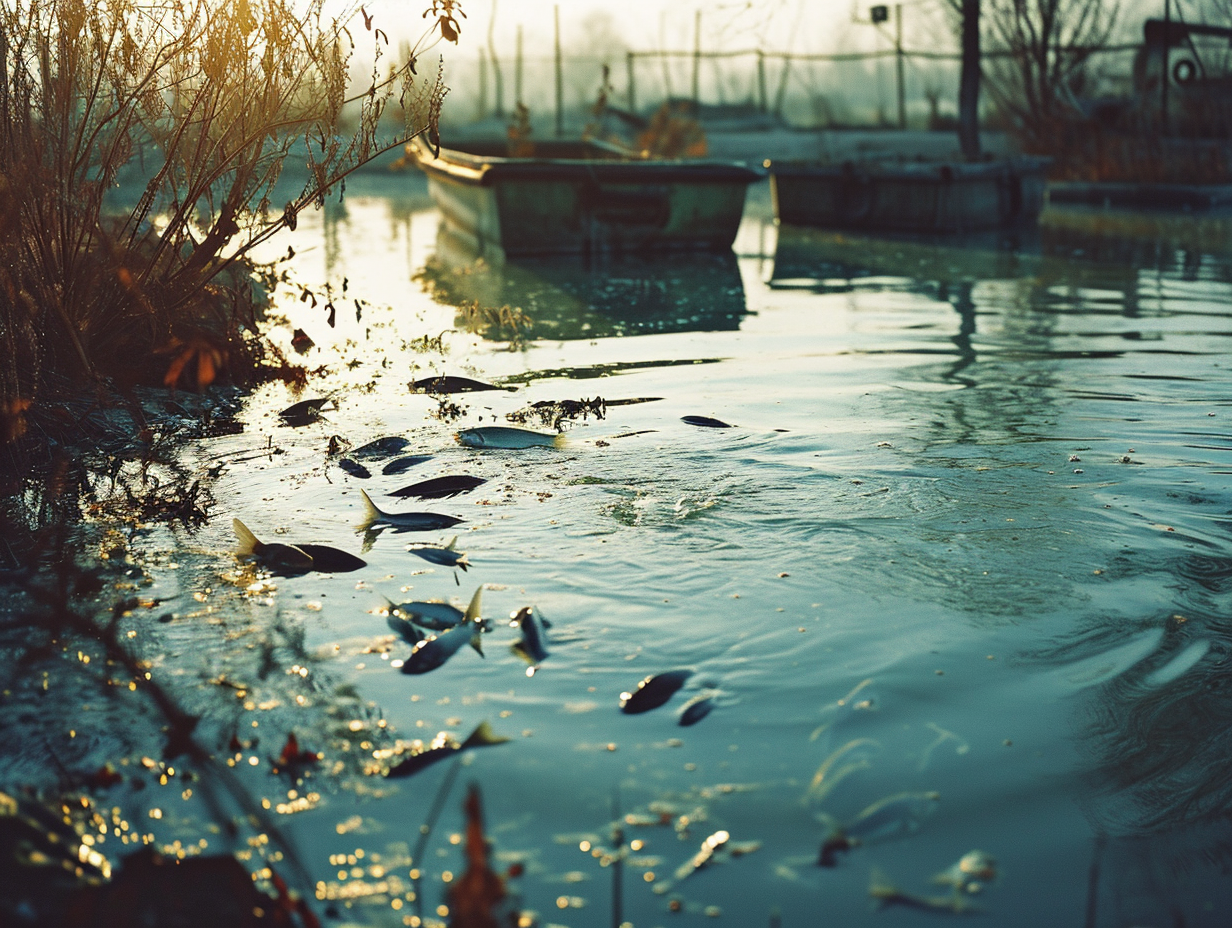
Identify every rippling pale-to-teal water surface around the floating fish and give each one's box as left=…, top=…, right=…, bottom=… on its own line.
left=141, top=179, right=1232, bottom=928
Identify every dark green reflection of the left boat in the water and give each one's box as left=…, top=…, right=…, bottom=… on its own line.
left=416, top=223, right=748, bottom=343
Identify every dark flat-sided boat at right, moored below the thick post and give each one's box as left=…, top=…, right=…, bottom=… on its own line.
left=770, top=158, right=1048, bottom=233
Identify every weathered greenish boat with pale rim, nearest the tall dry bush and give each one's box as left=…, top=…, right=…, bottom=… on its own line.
left=408, top=142, right=764, bottom=256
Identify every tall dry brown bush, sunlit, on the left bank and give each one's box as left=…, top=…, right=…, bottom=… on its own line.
left=0, top=0, right=462, bottom=440
